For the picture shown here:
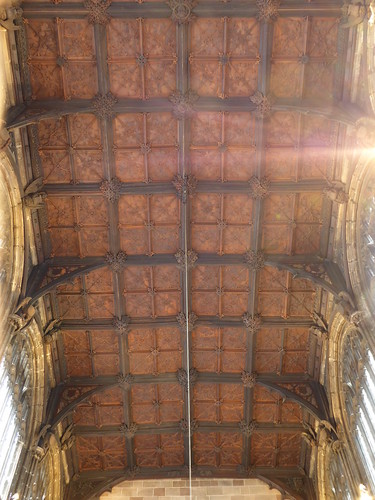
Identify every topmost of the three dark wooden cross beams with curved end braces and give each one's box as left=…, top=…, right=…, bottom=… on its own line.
left=7, top=96, right=366, bottom=130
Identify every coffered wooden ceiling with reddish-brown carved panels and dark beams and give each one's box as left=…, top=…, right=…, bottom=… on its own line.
left=10, top=0, right=353, bottom=498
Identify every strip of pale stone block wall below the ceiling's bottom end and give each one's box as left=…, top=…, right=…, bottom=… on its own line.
left=100, top=479, right=282, bottom=500
